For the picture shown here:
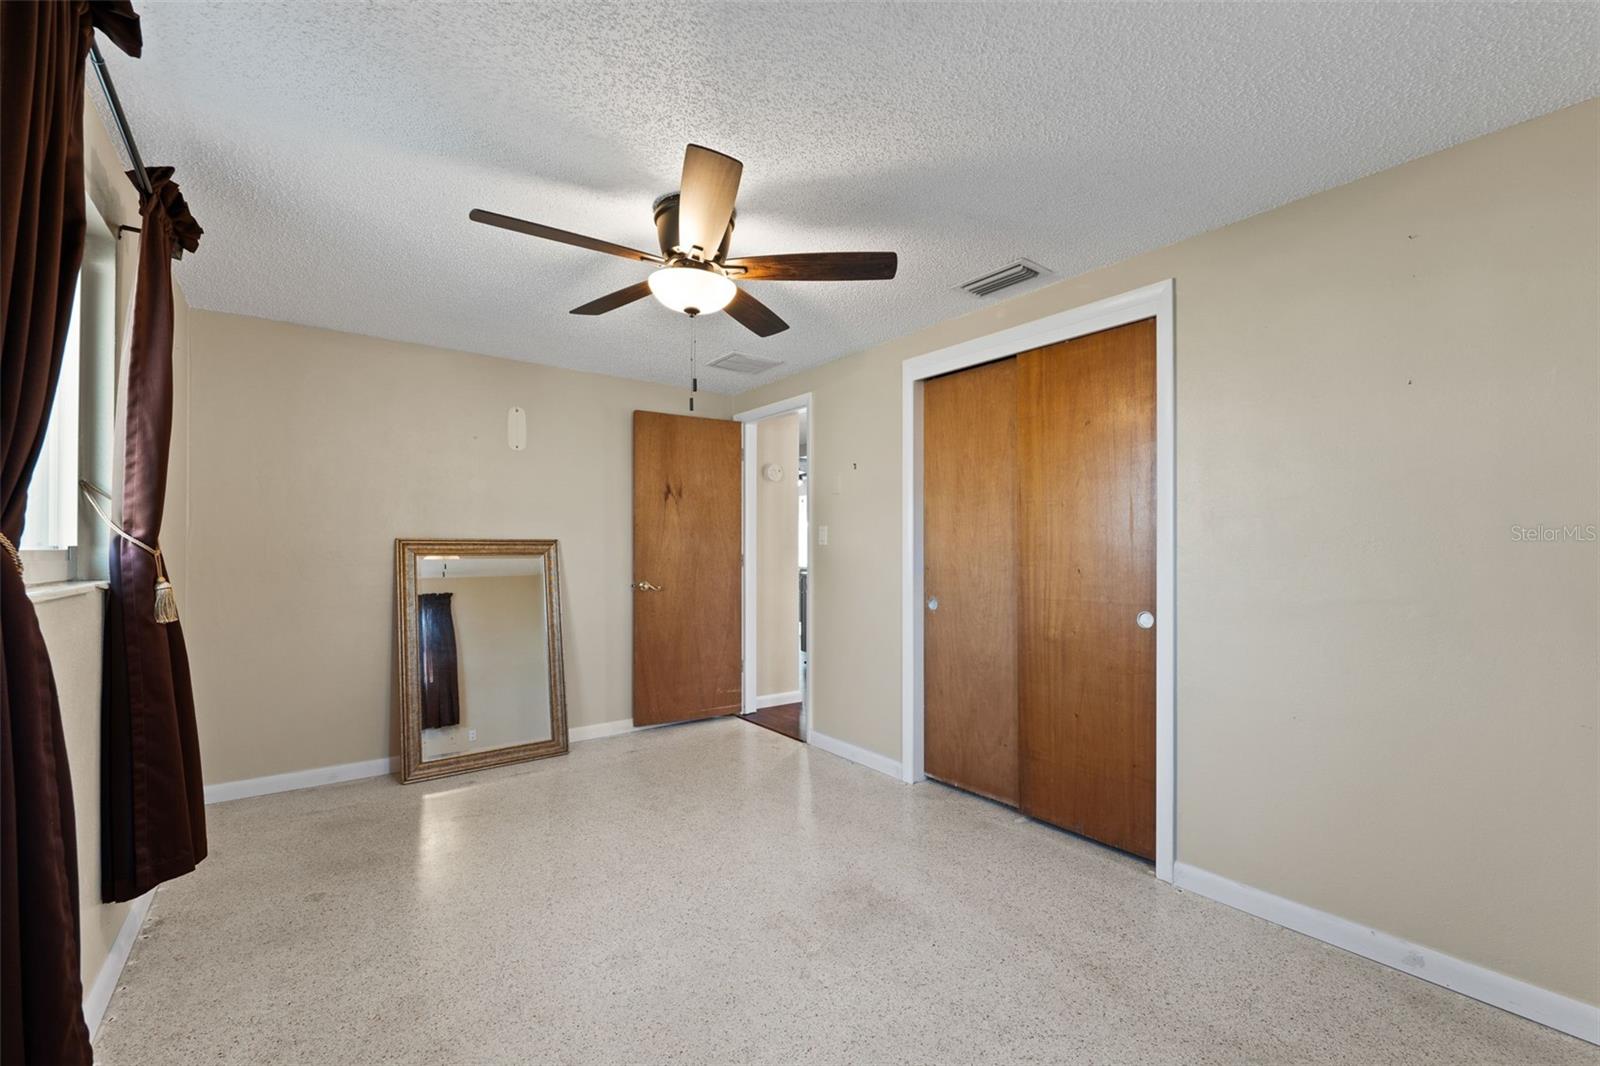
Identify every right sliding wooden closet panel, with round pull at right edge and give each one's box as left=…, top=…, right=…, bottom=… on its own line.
left=1017, top=319, right=1155, bottom=858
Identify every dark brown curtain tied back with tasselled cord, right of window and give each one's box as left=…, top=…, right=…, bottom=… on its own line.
left=101, top=166, right=206, bottom=900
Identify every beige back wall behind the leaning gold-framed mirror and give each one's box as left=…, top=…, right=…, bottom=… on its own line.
left=184, top=311, right=730, bottom=784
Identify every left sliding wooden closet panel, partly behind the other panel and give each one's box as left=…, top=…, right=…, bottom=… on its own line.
left=922, top=359, right=1018, bottom=807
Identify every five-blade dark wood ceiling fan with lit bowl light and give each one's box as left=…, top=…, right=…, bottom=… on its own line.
left=469, top=144, right=898, bottom=336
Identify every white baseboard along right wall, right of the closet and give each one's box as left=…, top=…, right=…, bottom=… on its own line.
left=1173, top=863, right=1600, bottom=1044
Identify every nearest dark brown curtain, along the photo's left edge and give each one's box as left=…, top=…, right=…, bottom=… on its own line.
left=0, top=0, right=139, bottom=1064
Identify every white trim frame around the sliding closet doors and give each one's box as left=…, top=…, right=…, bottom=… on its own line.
left=901, top=279, right=1178, bottom=882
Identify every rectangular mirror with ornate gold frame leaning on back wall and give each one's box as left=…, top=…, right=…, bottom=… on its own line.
left=395, top=539, right=566, bottom=781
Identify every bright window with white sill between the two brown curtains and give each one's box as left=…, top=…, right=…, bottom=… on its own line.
left=18, top=195, right=117, bottom=584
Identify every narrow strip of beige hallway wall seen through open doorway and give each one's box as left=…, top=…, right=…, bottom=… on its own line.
left=755, top=413, right=800, bottom=696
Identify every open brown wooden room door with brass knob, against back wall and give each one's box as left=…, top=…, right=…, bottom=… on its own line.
left=634, top=411, right=742, bottom=725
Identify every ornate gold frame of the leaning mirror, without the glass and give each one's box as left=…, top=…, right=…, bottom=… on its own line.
left=395, top=539, right=568, bottom=784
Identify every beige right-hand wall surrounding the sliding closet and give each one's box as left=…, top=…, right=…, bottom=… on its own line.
left=734, top=102, right=1600, bottom=1004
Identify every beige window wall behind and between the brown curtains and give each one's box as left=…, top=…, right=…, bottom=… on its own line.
left=37, top=106, right=198, bottom=1011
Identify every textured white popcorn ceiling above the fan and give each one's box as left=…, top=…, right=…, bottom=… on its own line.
left=107, top=0, right=1600, bottom=392
